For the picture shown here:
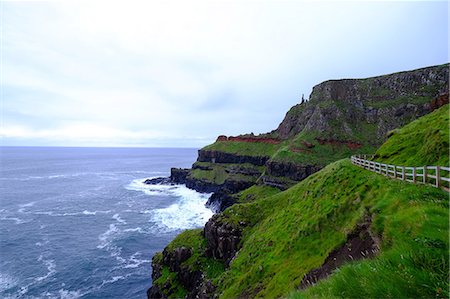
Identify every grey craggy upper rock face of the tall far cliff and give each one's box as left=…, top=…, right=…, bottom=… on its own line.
left=275, top=65, right=449, bottom=145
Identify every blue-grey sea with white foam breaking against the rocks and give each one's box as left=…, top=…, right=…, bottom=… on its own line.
left=0, top=147, right=213, bottom=298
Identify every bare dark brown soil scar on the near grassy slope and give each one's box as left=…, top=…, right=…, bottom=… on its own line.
left=300, top=218, right=380, bottom=289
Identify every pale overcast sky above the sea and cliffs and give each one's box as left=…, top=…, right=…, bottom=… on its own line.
left=0, top=0, right=449, bottom=147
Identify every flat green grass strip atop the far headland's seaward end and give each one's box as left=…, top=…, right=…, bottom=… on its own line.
left=202, top=141, right=280, bottom=157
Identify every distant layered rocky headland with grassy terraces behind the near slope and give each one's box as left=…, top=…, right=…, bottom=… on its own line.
left=172, top=64, right=449, bottom=197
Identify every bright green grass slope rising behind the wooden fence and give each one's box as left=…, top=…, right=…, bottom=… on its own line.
left=374, top=105, right=449, bottom=166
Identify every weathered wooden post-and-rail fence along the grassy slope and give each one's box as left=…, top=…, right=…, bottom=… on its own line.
left=351, top=155, right=450, bottom=192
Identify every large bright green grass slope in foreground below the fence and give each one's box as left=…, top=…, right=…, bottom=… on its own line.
left=217, top=160, right=448, bottom=298
